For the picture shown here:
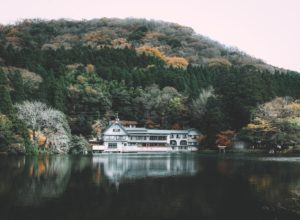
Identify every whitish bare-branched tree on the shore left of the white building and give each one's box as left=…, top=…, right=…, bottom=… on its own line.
left=16, top=101, right=71, bottom=152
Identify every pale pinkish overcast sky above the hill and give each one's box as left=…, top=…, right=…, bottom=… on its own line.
left=0, top=0, right=300, bottom=71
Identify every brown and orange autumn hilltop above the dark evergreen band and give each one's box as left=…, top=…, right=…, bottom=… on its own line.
left=0, top=18, right=285, bottom=72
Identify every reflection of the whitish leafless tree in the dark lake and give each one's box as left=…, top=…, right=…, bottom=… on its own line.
left=16, top=156, right=72, bottom=206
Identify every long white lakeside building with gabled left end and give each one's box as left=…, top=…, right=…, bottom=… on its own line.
left=95, top=120, right=199, bottom=152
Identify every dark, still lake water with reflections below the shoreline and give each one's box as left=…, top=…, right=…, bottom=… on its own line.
left=0, top=153, right=300, bottom=220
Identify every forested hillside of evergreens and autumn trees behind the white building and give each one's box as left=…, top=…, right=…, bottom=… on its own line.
left=0, top=19, right=300, bottom=152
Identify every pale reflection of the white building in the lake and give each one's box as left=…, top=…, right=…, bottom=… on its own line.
left=93, top=154, right=198, bottom=183
